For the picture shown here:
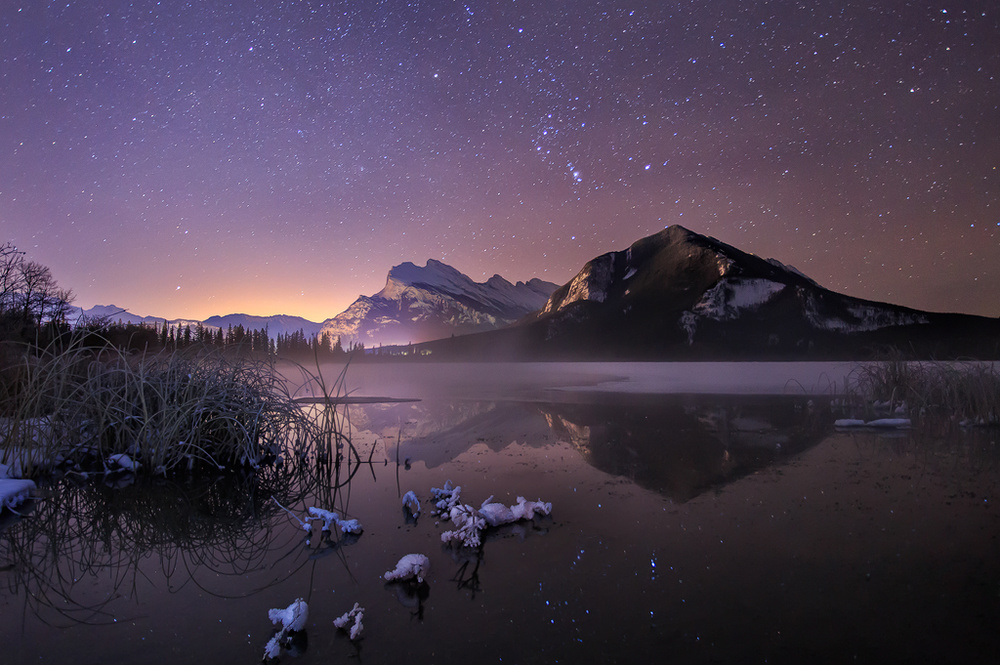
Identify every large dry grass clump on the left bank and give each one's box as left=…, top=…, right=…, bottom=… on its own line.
left=0, top=344, right=307, bottom=475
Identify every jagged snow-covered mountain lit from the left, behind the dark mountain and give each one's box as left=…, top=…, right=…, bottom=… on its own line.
left=322, top=259, right=556, bottom=347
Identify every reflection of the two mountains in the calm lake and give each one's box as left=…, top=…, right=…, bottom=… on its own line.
left=360, top=394, right=831, bottom=501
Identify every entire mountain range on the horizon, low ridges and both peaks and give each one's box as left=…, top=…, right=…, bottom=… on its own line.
left=70, top=226, right=1000, bottom=360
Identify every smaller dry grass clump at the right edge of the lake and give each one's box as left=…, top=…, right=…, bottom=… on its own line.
left=847, top=359, right=1000, bottom=426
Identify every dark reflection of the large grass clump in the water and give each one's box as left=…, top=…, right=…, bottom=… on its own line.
left=0, top=464, right=304, bottom=626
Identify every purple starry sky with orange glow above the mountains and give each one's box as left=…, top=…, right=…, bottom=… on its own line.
left=0, top=0, right=1000, bottom=321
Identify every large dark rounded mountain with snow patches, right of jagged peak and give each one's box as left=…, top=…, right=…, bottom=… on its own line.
left=422, top=226, right=1000, bottom=360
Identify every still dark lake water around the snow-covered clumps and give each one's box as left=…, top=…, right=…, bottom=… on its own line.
left=0, top=366, right=1000, bottom=663
